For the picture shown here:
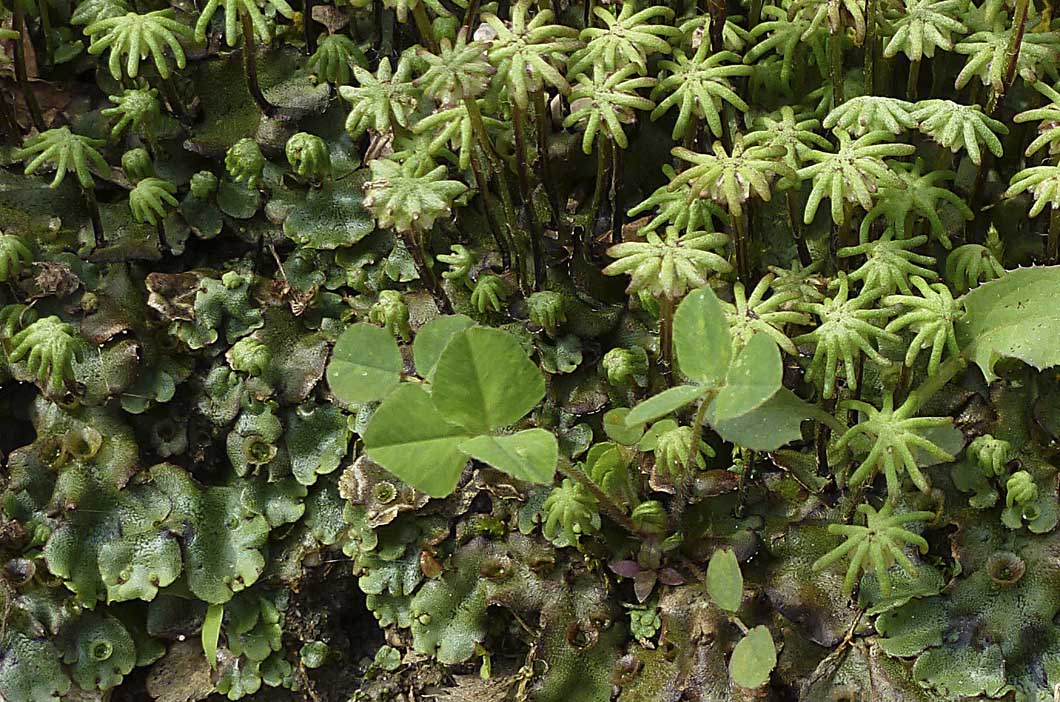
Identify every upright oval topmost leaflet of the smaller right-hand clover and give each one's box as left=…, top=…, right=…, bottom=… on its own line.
left=673, top=287, right=732, bottom=387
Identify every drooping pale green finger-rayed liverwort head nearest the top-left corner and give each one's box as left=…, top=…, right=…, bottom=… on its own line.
left=85, top=10, right=192, bottom=81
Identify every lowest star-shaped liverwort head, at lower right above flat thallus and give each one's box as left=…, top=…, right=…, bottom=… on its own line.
left=813, top=502, right=935, bottom=597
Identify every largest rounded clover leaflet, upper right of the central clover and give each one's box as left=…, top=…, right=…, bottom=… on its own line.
left=430, top=328, right=545, bottom=434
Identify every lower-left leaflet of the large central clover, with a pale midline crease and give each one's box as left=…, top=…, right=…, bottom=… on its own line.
left=363, top=385, right=470, bottom=497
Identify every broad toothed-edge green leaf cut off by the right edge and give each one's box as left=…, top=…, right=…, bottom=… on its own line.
left=956, top=266, right=1060, bottom=382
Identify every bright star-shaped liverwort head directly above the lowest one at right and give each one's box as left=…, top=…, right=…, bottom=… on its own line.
left=835, top=390, right=955, bottom=503
